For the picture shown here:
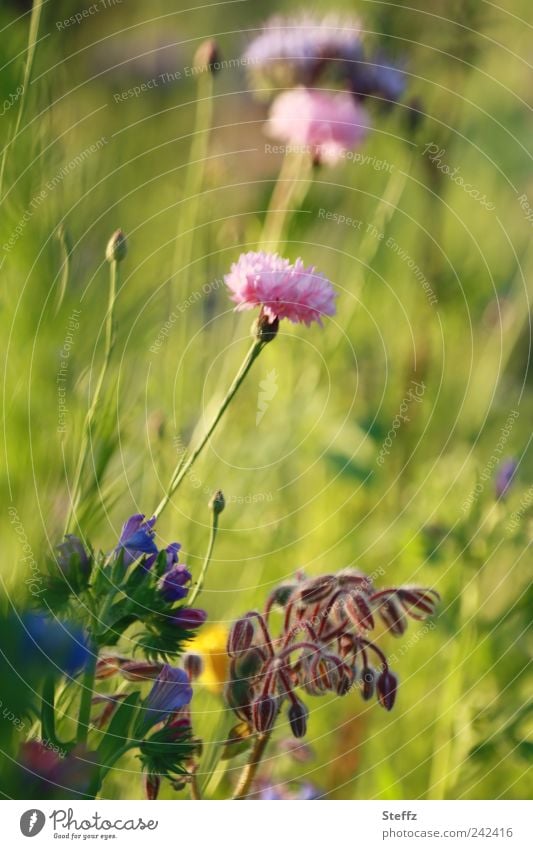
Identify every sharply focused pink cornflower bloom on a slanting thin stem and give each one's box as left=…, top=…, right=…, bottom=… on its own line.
left=225, top=251, right=336, bottom=325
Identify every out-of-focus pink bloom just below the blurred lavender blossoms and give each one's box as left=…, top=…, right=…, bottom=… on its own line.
left=266, top=86, right=369, bottom=165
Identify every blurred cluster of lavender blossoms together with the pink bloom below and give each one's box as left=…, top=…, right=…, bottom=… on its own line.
left=245, top=13, right=404, bottom=165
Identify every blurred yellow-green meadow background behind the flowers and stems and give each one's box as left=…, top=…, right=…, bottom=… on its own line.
left=0, top=0, right=533, bottom=799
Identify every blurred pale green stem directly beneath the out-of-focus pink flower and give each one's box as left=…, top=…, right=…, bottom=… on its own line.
left=259, top=154, right=313, bottom=253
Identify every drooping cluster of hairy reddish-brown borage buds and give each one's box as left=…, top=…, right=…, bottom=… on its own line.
left=226, top=569, right=438, bottom=738
